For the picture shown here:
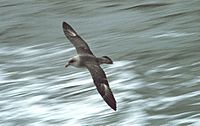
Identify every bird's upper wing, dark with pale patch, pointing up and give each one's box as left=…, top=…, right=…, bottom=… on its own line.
left=62, top=22, right=93, bottom=55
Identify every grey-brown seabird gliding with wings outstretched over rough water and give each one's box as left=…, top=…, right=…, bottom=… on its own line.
left=62, top=22, right=117, bottom=111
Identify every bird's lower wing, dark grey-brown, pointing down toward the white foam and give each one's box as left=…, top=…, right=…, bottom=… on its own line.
left=86, top=63, right=116, bottom=110
